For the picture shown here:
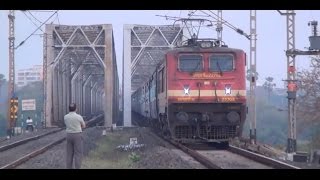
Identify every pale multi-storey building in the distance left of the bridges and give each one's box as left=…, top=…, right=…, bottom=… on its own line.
left=17, top=65, right=43, bottom=87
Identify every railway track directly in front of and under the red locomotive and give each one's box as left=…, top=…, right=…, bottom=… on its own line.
left=155, top=133, right=300, bottom=169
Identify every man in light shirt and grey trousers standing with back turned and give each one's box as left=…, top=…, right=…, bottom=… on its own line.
left=64, top=103, right=86, bottom=169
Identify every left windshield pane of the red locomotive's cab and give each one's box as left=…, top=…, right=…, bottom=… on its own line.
left=179, top=55, right=203, bottom=72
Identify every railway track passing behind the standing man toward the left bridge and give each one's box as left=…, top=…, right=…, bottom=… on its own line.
left=0, top=114, right=103, bottom=169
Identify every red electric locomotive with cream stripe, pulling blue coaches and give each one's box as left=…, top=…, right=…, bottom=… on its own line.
left=132, top=39, right=247, bottom=144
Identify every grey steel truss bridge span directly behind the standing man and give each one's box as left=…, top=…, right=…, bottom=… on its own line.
left=44, top=24, right=118, bottom=127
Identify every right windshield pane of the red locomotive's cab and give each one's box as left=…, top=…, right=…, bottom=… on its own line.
left=210, top=54, right=233, bottom=71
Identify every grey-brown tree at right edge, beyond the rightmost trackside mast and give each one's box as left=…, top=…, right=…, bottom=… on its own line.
left=297, top=56, right=320, bottom=147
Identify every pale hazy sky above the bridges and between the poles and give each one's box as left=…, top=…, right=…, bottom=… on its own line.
left=0, top=10, right=320, bottom=87
